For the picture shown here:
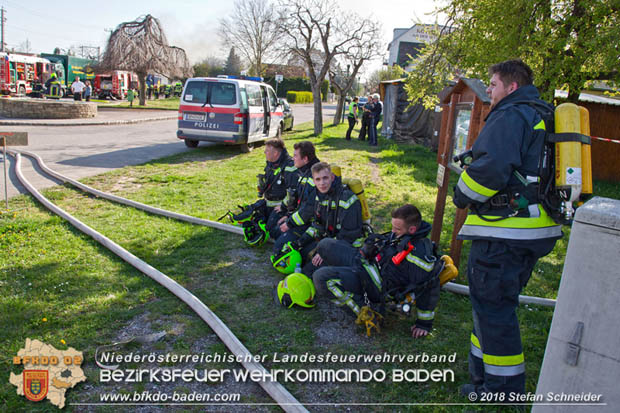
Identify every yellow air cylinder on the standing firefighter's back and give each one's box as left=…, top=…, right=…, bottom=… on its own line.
left=555, top=103, right=582, bottom=219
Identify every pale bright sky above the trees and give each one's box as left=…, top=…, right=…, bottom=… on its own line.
left=0, top=0, right=439, bottom=76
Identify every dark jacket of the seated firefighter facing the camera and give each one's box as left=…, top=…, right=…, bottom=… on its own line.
left=299, top=177, right=363, bottom=248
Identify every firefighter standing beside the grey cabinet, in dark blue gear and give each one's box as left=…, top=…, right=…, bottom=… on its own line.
left=454, top=60, right=562, bottom=401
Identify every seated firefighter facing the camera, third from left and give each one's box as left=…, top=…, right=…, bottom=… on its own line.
left=283, top=162, right=364, bottom=277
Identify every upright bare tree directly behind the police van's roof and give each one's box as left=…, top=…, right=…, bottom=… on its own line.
left=220, top=0, right=277, bottom=76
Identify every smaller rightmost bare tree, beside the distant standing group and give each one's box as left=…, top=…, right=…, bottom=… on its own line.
left=329, top=15, right=383, bottom=125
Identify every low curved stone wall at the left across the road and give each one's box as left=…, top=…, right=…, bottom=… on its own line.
left=0, top=98, right=97, bottom=119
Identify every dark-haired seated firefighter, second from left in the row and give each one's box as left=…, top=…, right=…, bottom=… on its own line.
left=272, top=141, right=319, bottom=254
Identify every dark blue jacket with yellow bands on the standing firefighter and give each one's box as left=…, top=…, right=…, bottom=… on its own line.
left=453, top=85, right=562, bottom=241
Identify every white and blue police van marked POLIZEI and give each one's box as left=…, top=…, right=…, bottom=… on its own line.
left=177, top=76, right=284, bottom=152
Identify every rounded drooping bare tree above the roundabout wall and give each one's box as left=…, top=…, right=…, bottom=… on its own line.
left=97, top=14, right=193, bottom=106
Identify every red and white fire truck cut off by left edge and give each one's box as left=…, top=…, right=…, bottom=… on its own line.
left=0, top=53, right=58, bottom=96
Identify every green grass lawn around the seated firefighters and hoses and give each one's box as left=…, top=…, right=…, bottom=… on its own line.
left=0, top=119, right=620, bottom=412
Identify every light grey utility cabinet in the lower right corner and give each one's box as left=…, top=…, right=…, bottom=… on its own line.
left=532, top=197, right=620, bottom=413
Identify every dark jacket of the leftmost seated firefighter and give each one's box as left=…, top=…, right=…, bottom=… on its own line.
left=258, top=149, right=299, bottom=207
